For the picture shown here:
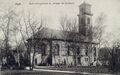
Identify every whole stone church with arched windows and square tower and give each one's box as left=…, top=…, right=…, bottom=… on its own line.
left=27, top=2, right=98, bottom=66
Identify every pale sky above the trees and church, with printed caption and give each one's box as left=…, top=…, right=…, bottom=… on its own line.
left=0, top=0, right=120, bottom=45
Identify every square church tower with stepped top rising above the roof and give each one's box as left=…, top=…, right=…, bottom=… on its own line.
left=78, top=2, right=93, bottom=38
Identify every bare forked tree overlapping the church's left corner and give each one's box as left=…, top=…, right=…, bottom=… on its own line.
left=19, top=13, right=45, bottom=70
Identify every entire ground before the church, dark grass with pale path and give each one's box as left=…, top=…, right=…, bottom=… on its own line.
left=1, top=66, right=116, bottom=75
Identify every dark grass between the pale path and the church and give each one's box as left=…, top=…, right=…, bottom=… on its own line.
left=37, top=66, right=113, bottom=73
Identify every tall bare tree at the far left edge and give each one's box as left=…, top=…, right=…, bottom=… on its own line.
left=0, top=9, right=17, bottom=66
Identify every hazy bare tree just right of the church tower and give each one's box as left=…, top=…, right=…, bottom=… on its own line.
left=93, top=13, right=106, bottom=48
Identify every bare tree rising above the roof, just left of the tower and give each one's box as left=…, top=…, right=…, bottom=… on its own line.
left=60, top=16, right=79, bottom=64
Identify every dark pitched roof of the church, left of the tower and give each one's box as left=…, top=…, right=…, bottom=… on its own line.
left=29, top=28, right=96, bottom=42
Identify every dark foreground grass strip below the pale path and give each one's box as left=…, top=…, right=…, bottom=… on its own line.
left=1, top=70, right=89, bottom=75
